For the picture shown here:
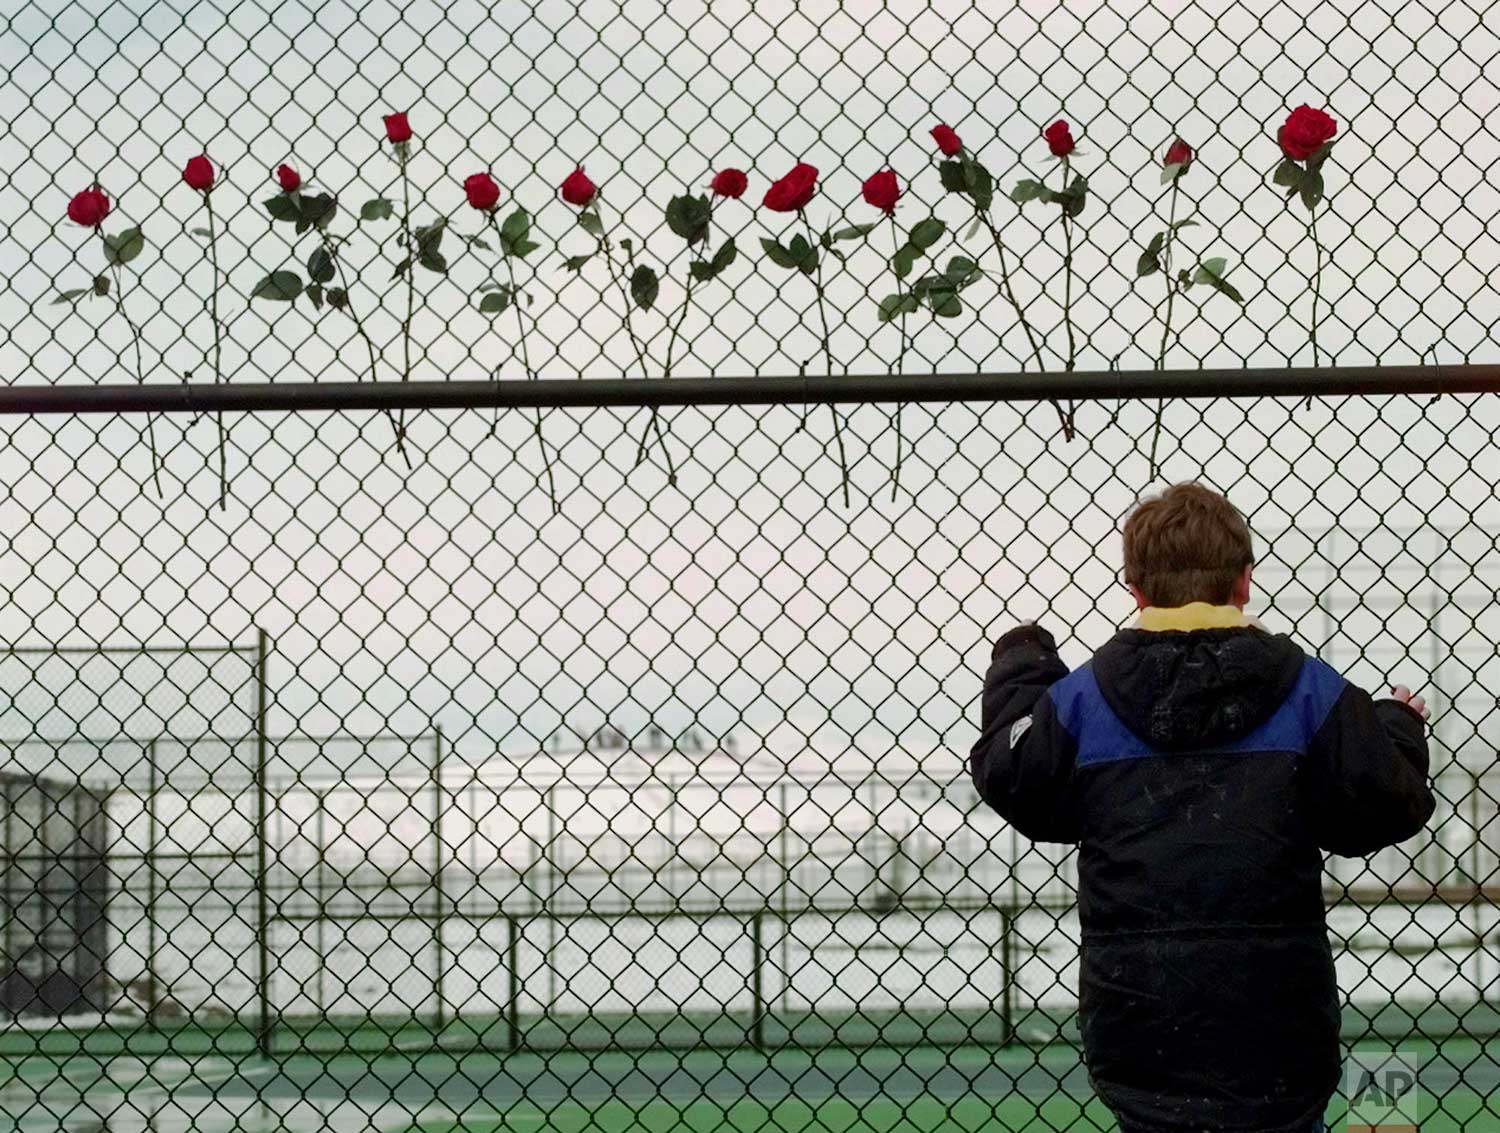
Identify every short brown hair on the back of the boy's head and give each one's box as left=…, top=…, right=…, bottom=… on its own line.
left=1125, top=482, right=1256, bottom=606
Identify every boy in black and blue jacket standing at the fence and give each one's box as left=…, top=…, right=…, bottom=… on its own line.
left=971, top=483, right=1434, bottom=1133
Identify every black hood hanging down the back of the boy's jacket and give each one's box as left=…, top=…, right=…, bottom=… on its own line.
left=1094, top=627, right=1307, bottom=750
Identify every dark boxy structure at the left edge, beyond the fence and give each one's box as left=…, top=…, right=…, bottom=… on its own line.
left=0, top=771, right=108, bottom=1017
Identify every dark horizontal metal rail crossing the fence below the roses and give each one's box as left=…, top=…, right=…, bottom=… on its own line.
left=0, top=363, right=1500, bottom=414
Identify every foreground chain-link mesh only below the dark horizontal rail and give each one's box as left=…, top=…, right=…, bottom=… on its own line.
left=0, top=396, right=1500, bottom=1130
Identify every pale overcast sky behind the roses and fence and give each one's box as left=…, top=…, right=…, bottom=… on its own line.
left=0, top=0, right=1500, bottom=804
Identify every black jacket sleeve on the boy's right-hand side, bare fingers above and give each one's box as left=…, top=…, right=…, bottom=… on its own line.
left=1308, top=681, right=1436, bottom=857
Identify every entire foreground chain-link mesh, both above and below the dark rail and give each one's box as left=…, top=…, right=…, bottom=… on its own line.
left=0, top=0, right=1500, bottom=1133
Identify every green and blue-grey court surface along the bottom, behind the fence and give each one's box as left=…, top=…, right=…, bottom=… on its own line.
left=0, top=1035, right=1500, bottom=1133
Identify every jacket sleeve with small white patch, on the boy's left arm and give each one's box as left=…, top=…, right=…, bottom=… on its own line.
left=969, top=626, right=1079, bottom=842
